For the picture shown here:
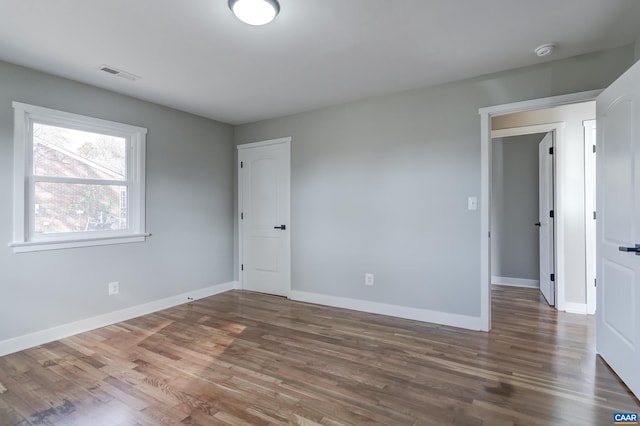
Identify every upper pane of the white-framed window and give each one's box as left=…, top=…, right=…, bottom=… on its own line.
left=33, top=123, right=127, bottom=180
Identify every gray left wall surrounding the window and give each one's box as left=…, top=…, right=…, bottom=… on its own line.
left=0, top=62, right=234, bottom=340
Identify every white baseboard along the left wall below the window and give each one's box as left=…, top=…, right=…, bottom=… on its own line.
left=0, top=281, right=239, bottom=356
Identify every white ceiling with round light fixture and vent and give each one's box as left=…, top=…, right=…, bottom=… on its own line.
left=0, top=0, right=640, bottom=124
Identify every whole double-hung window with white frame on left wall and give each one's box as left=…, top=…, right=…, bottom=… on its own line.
left=11, top=102, right=148, bottom=252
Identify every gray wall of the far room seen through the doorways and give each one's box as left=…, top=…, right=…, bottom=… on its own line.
left=491, top=134, right=544, bottom=280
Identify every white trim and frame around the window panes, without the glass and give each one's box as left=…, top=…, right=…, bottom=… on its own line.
left=9, top=102, right=151, bottom=253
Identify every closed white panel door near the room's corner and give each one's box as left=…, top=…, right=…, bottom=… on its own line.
left=238, top=138, right=291, bottom=296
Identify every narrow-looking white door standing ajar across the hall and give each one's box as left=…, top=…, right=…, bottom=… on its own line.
left=538, top=132, right=556, bottom=306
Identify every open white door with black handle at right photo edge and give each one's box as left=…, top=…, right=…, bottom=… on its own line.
left=596, top=58, right=640, bottom=397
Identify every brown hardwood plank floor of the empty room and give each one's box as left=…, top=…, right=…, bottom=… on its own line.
left=0, top=287, right=640, bottom=426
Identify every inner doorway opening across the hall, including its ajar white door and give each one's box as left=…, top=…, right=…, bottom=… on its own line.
left=491, top=131, right=556, bottom=306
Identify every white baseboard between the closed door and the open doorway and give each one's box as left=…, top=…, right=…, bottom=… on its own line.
left=289, top=290, right=482, bottom=331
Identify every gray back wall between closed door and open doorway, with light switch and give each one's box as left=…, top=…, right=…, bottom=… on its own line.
left=234, top=45, right=634, bottom=316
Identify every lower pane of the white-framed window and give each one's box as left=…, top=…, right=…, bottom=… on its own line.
left=34, top=182, right=127, bottom=234
